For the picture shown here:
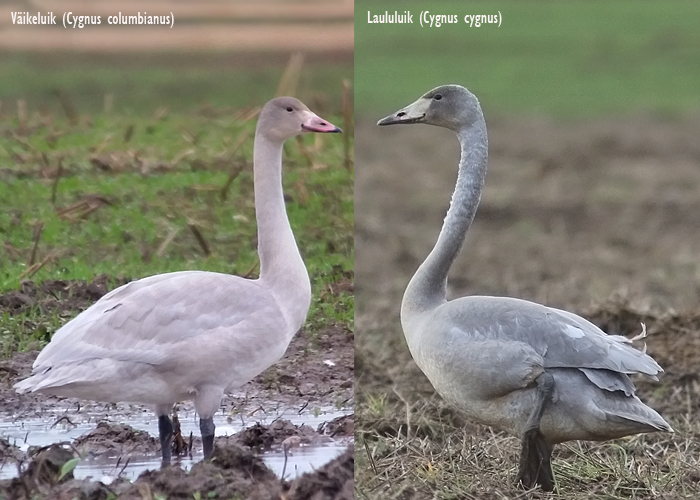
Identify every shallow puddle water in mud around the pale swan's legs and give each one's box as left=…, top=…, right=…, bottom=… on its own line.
left=0, top=408, right=352, bottom=483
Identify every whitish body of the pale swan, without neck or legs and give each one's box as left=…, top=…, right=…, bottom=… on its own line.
left=17, top=271, right=294, bottom=404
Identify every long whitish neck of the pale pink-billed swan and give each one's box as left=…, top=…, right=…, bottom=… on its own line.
left=253, top=131, right=311, bottom=328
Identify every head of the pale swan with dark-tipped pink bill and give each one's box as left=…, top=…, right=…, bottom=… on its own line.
left=257, top=97, right=342, bottom=141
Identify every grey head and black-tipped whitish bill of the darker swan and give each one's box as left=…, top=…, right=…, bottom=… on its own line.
left=377, top=85, right=482, bottom=131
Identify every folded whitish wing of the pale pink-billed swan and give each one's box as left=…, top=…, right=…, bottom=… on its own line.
left=34, top=271, right=277, bottom=372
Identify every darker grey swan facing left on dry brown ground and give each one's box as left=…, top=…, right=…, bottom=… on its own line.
left=378, top=85, right=672, bottom=491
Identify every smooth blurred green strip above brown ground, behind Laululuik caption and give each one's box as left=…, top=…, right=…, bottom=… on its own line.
left=355, top=0, right=700, bottom=118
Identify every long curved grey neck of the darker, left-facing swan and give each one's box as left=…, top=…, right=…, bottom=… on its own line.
left=401, top=114, right=488, bottom=320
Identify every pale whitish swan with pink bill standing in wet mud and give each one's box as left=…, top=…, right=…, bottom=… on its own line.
left=15, top=97, right=340, bottom=464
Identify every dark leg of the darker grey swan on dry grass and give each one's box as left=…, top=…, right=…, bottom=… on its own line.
left=517, top=372, right=554, bottom=491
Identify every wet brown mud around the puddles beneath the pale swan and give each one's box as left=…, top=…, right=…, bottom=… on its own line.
left=0, top=275, right=354, bottom=499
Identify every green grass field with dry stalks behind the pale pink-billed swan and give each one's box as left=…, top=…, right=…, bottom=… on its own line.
left=0, top=60, right=354, bottom=355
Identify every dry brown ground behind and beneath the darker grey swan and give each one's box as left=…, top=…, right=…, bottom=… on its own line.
left=355, top=116, right=700, bottom=498
